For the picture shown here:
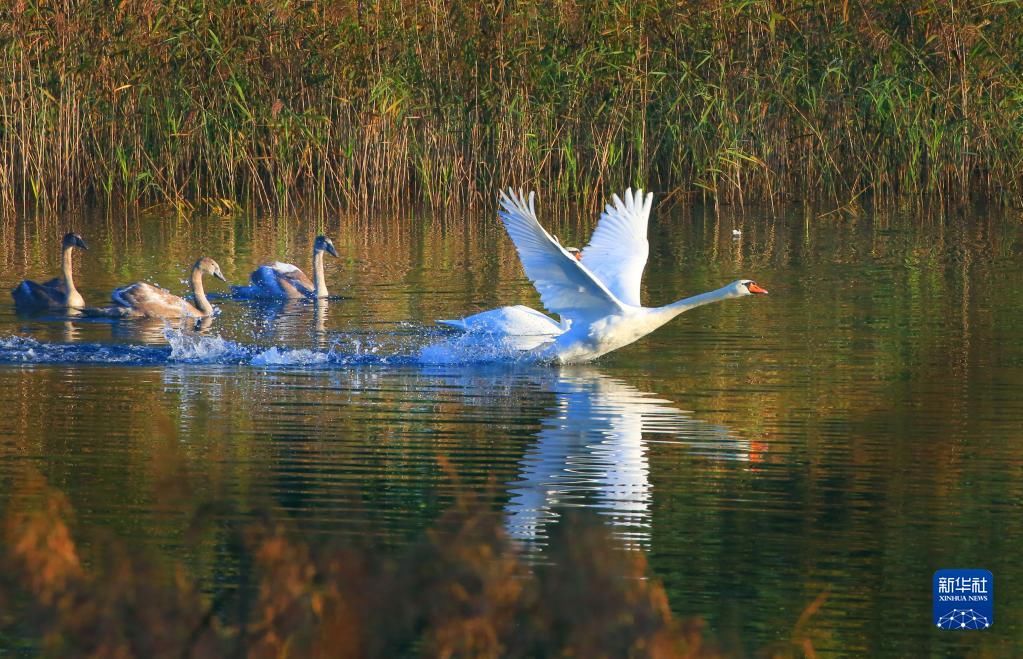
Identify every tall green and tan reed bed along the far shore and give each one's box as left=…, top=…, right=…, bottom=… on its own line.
left=0, top=0, right=1023, bottom=213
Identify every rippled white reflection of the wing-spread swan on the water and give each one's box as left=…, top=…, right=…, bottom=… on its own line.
left=433, top=366, right=751, bottom=546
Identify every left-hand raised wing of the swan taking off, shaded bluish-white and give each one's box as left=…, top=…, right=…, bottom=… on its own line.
left=498, top=189, right=623, bottom=319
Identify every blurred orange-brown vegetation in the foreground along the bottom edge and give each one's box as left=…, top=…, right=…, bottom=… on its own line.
left=0, top=472, right=819, bottom=657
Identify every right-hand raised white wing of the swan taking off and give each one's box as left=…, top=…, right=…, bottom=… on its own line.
left=582, top=188, right=654, bottom=307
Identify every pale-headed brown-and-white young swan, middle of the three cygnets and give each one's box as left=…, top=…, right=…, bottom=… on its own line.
left=86, top=256, right=227, bottom=318
